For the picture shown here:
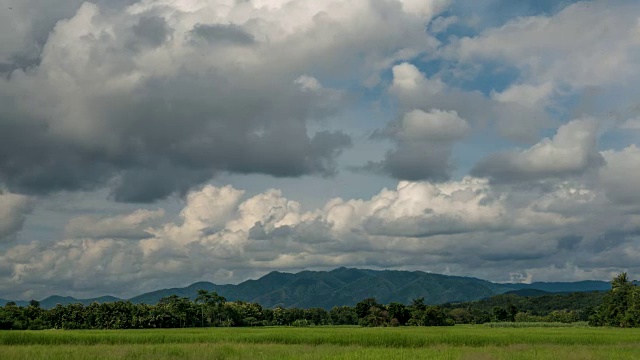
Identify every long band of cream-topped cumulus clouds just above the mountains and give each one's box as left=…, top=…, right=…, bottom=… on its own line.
left=0, top=177, right=640, bottom=296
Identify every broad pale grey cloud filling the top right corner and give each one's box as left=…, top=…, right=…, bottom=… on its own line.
left=444, top=1, right=640, bottom=88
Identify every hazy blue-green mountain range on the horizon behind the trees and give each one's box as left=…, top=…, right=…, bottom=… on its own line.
left=0, top=267, right=611, bottom=309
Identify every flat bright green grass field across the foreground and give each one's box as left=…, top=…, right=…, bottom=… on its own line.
left=0, top=326, right=640, bottom=360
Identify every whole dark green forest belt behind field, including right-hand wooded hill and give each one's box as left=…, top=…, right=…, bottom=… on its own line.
left=0, top=273, right=640, bottom=330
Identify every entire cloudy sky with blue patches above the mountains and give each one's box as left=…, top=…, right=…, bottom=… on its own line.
left=0, top=0, right=640, bottom=299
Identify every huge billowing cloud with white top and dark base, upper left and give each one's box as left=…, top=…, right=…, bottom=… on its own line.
left=0, top=0, right=447, bottom=202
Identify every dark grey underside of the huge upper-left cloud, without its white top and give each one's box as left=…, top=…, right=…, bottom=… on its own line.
left=0, top=71, right=351, bottom=202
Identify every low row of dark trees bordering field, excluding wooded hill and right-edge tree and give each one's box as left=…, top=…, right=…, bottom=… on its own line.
left=0, top=290, right=596, bottom=330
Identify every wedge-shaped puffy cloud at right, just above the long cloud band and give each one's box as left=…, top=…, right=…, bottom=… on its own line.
left=472, top=119, right=604, bottom=182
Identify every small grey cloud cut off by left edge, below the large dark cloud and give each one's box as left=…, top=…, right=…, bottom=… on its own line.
left=0, top=190, right=33, bottom=244
